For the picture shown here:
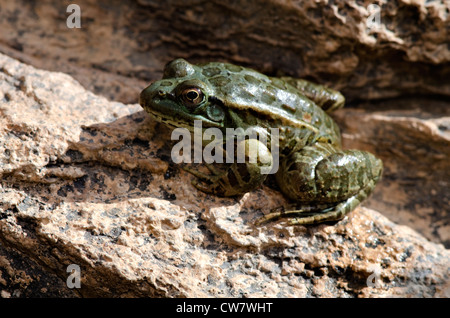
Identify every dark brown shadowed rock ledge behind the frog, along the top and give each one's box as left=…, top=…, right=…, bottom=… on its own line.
left=0, top=0, right=450, bottom=103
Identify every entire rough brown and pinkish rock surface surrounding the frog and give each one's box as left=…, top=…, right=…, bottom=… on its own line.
left=0, top=0, right=450, bottom=297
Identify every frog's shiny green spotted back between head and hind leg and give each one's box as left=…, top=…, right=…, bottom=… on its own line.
left=196, top=62, right=340, bottom=146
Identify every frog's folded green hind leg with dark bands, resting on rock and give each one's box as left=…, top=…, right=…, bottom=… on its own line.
left=259, top=143, right=383, bottom=224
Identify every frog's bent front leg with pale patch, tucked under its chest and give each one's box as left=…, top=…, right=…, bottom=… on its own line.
left=184, top=139, right=273, bottom=197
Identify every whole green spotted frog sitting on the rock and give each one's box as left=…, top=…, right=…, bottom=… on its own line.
left=139, top=58, right=383, bottom=225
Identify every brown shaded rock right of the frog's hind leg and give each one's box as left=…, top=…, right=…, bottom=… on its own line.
left=334, top=97, right=450, bottom=248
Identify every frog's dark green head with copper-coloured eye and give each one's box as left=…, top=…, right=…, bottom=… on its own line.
left=139, top=59, right=226, bottom=131
